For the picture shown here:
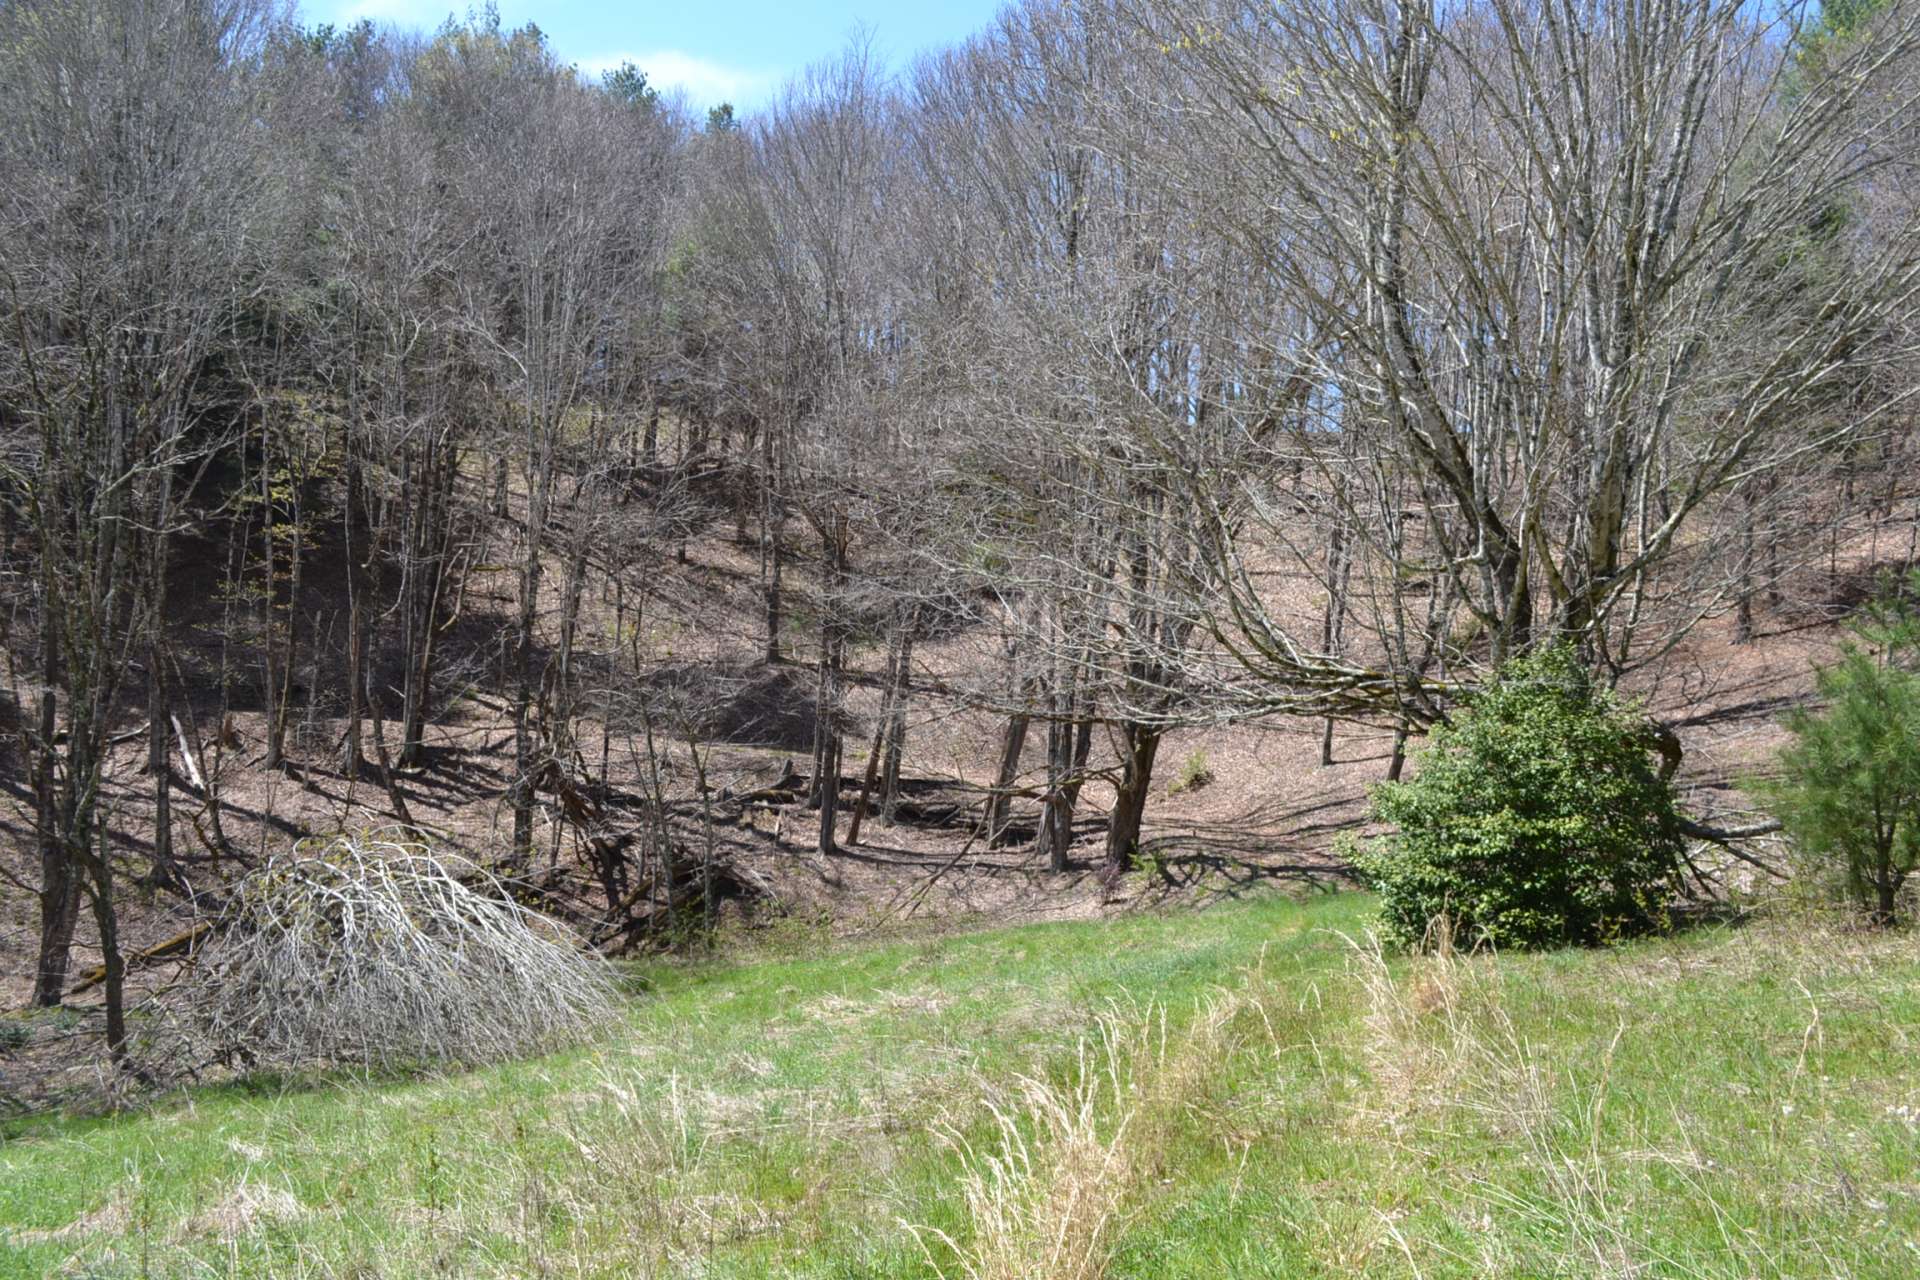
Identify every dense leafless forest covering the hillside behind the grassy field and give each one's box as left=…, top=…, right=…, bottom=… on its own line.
left=0, top=0, right=1920, bottom=1074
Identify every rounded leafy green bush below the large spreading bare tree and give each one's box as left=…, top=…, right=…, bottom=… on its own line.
left=1356, top=649, right=1684, bottom=946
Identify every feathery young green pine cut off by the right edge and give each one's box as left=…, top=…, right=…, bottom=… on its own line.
left=1753, top=574, right=1920, bottom=923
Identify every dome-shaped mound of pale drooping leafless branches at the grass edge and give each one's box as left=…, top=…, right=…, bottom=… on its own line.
left=177, top=837, right=612, bottom=1069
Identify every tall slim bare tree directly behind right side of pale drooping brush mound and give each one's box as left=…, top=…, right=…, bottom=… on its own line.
left=415, top=25, right=655, bottom=862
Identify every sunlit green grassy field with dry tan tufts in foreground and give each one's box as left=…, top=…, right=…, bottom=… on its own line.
left=0, top=894, right=1920, bottom=1280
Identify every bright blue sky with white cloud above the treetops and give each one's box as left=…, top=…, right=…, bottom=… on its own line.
left=300, top=0, right=1000, bottom=109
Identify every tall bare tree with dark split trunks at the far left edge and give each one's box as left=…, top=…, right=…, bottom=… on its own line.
left=0, top=0, right=276, bottom=1055
